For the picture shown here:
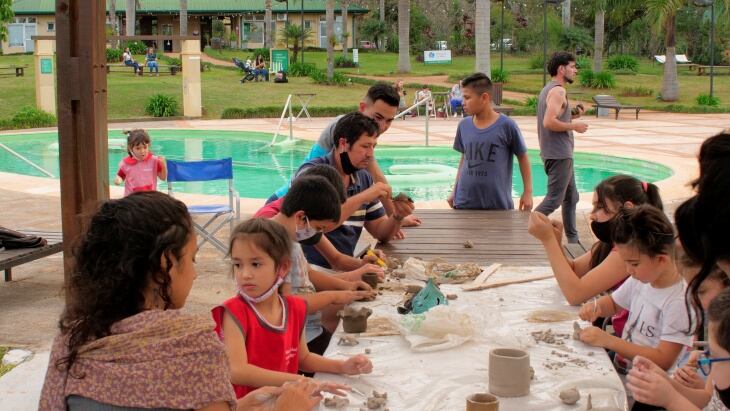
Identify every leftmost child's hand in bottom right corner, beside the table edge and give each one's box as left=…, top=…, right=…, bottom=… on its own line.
left=626, top=356, right=677, bottom=407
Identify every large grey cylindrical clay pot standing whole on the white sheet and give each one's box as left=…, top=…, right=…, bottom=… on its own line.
left=489, top=348, right=530, bottom=397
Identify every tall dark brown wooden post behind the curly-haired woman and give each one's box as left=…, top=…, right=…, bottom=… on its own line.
left=56, top=0, right=109, bottom=292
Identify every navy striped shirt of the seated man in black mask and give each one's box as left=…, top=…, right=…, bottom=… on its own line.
left=297, top=151, right=385, bottom=268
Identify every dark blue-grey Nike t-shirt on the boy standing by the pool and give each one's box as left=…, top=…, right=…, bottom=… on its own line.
left=454, top=115, right=527, bottom=210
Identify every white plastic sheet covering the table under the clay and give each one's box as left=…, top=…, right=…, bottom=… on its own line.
left=315, top=267, right=627, bottom=411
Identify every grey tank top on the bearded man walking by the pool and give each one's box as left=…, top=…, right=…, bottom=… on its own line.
left=537, top=80, right=575, bottom=160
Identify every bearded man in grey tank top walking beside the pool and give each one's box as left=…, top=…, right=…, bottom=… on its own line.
left=535, top=51, right=588, bottom=243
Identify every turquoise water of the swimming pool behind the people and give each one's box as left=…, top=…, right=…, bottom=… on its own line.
left=0, top=129, right=672, bottom=200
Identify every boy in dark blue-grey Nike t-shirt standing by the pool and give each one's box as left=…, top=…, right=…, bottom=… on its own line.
left=447, top=73, right=532, bottom=211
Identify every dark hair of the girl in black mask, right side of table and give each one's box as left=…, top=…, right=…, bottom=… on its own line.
left=591, top=174, right=664, bottom=268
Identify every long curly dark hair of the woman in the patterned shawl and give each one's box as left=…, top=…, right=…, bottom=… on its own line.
left=56, top=191, right=193, bottom=377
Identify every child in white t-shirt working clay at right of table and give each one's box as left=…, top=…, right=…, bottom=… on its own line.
left=580, top=205, right=691, bottom=374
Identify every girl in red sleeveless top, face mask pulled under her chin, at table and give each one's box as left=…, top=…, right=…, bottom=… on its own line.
left=212, top=218, right=372, bottom=398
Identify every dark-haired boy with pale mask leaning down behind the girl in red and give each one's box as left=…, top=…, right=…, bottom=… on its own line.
left=253, top=172, right=374, bottom=355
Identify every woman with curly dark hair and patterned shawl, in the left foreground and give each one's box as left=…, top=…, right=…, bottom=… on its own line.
left=38, top=191, right=321, bottom=411
